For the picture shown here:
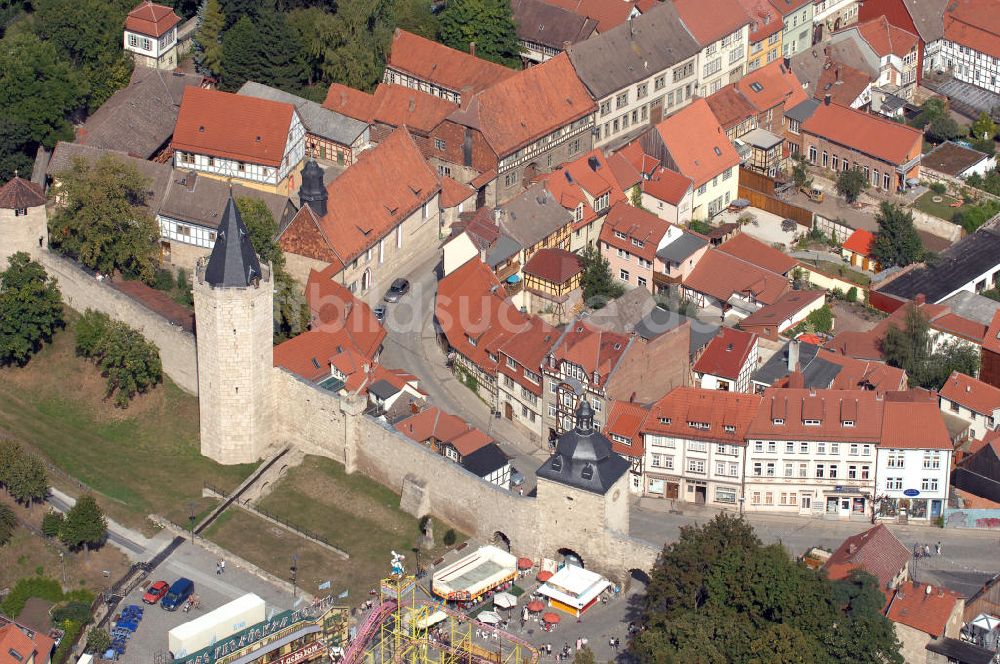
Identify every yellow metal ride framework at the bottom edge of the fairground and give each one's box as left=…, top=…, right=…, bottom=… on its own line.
left=363, top=576, right=538, bottom=664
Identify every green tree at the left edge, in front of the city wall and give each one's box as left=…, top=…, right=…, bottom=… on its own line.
left=0, top=252, right=64, bottom=366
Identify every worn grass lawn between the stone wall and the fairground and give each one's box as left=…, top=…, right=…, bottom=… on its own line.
left=231, top=456, right=465, bottom=597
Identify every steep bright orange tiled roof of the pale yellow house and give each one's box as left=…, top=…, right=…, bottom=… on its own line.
left=656, top=98, right=742, bottom=187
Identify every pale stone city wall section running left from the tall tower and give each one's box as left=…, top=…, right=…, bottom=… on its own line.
left=39, top=251, right=198, bottom=395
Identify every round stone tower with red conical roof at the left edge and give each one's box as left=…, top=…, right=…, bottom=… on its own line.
left=0, top=175, right=49, bottom=271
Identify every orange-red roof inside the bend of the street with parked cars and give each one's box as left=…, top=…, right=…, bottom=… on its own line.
left=434, top=260, right=529, bottom=374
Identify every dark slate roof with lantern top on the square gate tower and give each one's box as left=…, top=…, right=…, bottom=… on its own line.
left=536, top=400, right=629, bottom=496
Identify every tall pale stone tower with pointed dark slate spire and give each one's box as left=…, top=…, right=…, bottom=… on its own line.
left=194, top=195, right=274, bottom=464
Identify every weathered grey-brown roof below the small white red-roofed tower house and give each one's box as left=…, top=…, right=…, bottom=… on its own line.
left=76, top=67, right=204, bottom=159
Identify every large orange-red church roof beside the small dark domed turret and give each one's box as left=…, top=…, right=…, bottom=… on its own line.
left=279, top=128, right=441, bottom=266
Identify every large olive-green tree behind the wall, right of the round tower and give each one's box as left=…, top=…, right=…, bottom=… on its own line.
left=49, top=155, right=160, bottom=283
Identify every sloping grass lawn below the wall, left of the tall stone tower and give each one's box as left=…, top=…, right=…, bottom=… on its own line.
left=0, top=312, right=253, bottom=527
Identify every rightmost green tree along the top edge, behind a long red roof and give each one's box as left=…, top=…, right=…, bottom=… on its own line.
left=441, top=0, right=521, bottom=67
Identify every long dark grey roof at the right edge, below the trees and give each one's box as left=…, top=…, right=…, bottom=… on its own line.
left=876, top=227, right=1000, bottom=303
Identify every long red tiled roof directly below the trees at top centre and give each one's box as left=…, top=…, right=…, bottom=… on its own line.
left=386, top=28, right=515, bottom=94
